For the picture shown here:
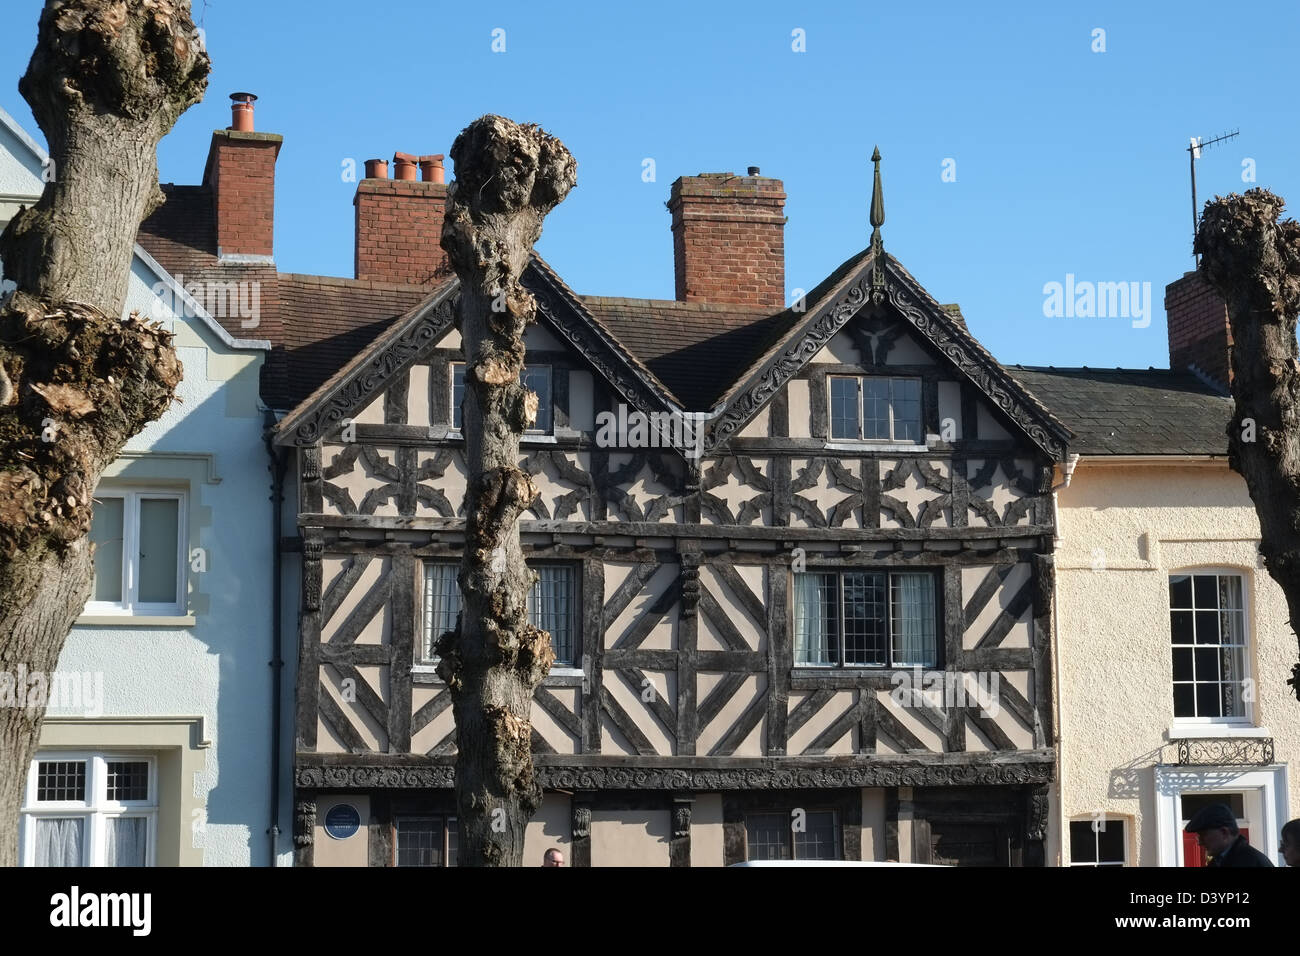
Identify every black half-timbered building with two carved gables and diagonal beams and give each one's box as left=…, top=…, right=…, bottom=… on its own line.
left=274, top=157, right=1070, bottom=866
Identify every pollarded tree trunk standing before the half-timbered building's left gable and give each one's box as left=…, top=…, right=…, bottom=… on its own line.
left=438, top=116, right=577, bottom=866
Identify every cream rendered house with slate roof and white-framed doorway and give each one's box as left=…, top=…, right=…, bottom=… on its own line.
left=1010, top=276, right=1300, bottom=866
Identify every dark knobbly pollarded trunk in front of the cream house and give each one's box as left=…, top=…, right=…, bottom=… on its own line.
left=1196, top=189, right=1300, bottom=697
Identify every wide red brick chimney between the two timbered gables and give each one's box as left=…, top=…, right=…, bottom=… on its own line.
left=668, top=166, right=785, bottom=310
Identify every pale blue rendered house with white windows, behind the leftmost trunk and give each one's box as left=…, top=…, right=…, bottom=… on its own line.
left=0, top=109, right=291, bottom=866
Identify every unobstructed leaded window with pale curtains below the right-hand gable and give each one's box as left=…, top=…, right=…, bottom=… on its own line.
left=794, top=571, right=939, bottom=667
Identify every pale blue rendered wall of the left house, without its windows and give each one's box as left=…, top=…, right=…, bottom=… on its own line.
left=0, top=106, right=298, bottom=866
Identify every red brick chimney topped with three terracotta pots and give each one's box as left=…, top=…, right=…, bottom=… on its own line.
left=352, top=152, right=451, bottom=285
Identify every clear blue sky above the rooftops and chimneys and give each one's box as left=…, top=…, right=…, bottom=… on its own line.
left=0, top=0, right=1300, bottom=367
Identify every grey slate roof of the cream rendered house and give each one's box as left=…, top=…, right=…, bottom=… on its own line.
left=1004, top=365, right=1232, bottom=455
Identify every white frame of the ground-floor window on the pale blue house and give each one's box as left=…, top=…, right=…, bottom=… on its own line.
left=18, top=750, right=159, bottom=866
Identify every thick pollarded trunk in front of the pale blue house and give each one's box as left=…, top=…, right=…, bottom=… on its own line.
left=0, top=0, right=211, bottom=866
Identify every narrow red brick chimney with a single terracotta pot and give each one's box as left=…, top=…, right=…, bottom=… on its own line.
left=203, top=92, right=285, bottom=261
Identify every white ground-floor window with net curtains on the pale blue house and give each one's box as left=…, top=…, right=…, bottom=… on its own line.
left=21, top=750, right=157, bottom=866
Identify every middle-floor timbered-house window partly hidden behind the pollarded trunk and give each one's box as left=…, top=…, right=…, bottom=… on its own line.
left=424, top=561, right=579, bottom=667
